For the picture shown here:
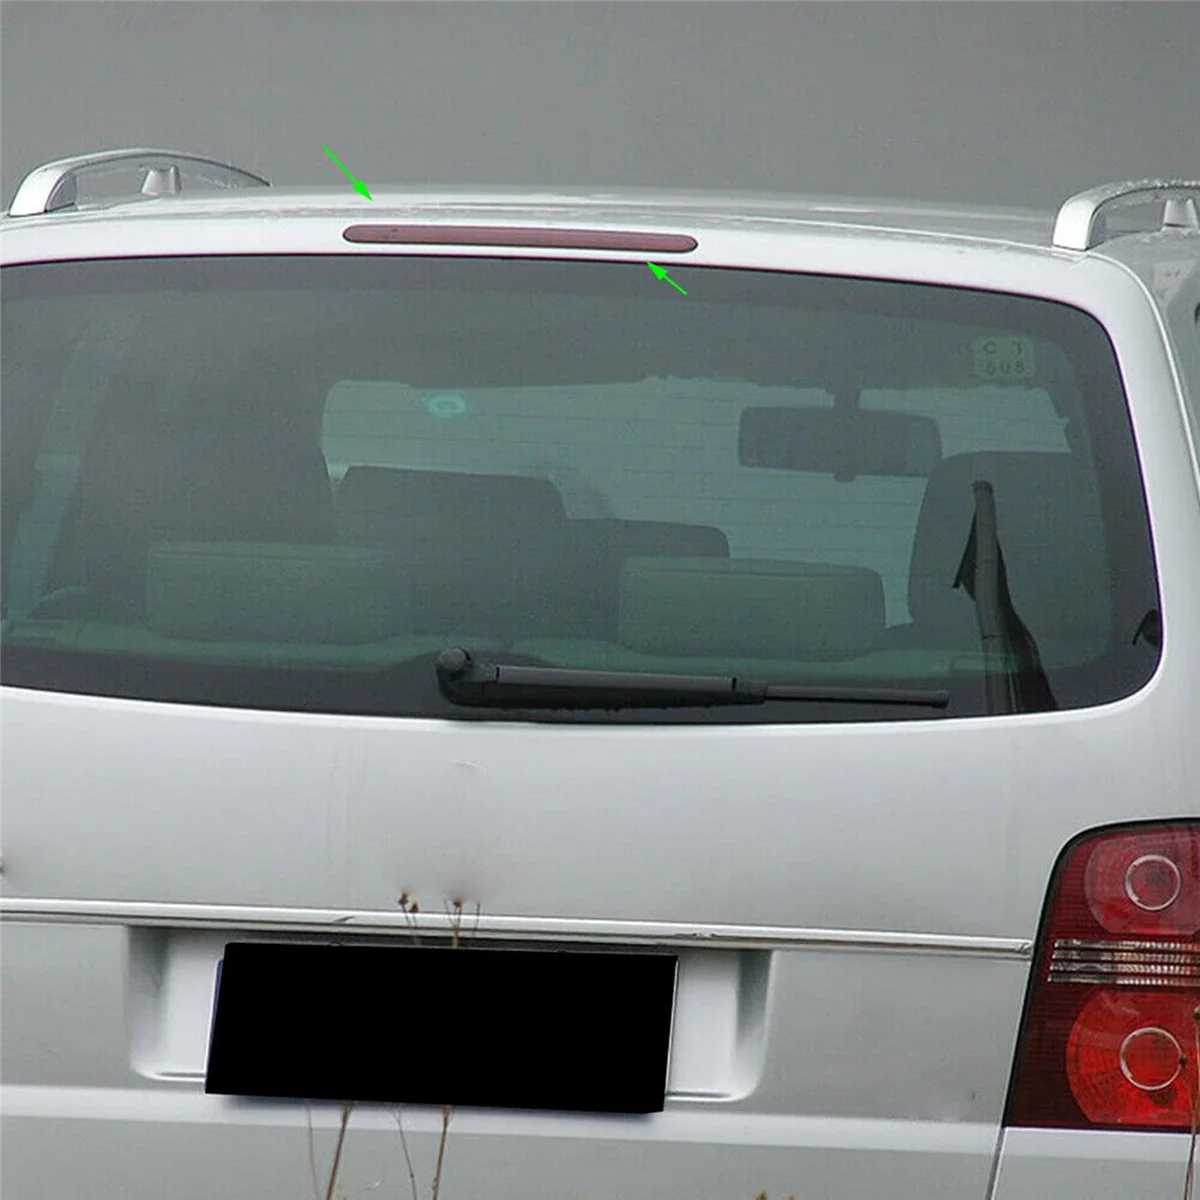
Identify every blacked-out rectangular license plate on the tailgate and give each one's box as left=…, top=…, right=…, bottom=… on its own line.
left=204, top=942, right=677, bottom=1112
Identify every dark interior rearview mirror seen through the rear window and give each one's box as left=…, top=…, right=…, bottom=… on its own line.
left=738, top=408, right=942, bottom=479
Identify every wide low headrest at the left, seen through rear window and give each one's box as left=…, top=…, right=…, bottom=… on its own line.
left=146, top=541, right=406, bottom=644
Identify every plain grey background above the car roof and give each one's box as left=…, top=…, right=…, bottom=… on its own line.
left=0, top=0, right=1200, bottom=206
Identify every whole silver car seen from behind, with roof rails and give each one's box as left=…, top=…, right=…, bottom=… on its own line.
left=0, top=150, right=1200, bottom=1200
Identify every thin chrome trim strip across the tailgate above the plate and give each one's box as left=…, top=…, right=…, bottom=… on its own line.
left=0, top=896, right=1033, bottom=959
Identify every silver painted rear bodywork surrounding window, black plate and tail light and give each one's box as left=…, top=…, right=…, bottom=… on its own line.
left=0, top=182, right=1200, bottom=1200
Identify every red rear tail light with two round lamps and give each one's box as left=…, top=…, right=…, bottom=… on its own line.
left=1004, top=821, right=1200, bottom=1132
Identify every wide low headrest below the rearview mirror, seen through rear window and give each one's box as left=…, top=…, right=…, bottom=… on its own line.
left=618, top=558, right=884, bottom=661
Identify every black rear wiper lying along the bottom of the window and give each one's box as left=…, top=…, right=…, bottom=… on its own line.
left=433, top=649, right=950, bottom=709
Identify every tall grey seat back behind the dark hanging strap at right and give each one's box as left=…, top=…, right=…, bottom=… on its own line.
left=908, top=450, right=1112, bottom=658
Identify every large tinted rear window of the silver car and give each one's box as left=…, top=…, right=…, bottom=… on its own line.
left=0, top=256, right=1160, bottom=722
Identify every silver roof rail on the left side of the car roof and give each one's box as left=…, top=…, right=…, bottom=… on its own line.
left=8, top=148, right=270, bottom=217
